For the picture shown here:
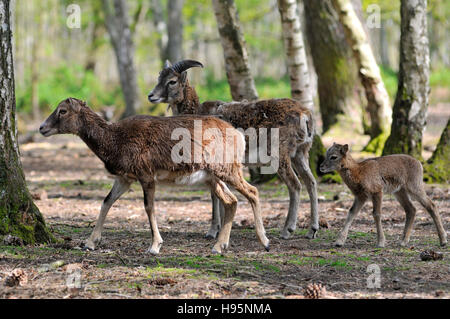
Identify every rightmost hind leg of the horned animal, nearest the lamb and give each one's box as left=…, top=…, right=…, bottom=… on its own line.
left=293, top=150, right=319, bottom=239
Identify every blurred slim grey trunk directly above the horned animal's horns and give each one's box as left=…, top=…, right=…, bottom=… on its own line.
left=166, top=0, right=184, bottom=63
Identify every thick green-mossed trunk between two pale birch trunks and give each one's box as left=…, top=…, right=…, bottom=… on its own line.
left=304, top=0, right=362, bottom=133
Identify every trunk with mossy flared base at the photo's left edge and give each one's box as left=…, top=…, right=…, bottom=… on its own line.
left=0, top=0, right=52, bottom=243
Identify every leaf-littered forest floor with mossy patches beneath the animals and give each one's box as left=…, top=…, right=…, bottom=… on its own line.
left=0, top=102, right=450, bottom=298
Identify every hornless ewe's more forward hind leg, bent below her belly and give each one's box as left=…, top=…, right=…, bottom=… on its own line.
left=211, top=180, right=237, bottom=254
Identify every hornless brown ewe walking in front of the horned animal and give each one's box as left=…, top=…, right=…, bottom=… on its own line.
left=39, top=98, right=269, bottom=254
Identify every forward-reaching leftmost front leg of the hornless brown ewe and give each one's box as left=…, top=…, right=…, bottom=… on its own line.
left=84, top=177, right=132, bottom=250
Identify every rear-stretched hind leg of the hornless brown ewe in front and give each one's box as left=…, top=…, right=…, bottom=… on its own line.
left=225, top=170, right=269, bottom=251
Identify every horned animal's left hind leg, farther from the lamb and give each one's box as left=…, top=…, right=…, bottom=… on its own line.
left=278, top=155, right=302, bottom=239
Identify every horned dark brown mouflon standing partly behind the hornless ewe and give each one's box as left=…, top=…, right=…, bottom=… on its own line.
left=148, top=60, right=319, bottom=239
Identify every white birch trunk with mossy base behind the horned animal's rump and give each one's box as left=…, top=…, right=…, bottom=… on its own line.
left=278, top=0, right=325, bottom=177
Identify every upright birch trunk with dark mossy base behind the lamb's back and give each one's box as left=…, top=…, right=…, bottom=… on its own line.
left=383, top=0, right=430, bottom=159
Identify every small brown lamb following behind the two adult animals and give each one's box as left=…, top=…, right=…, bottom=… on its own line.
left=320, top=143, right=447, bottom=247
